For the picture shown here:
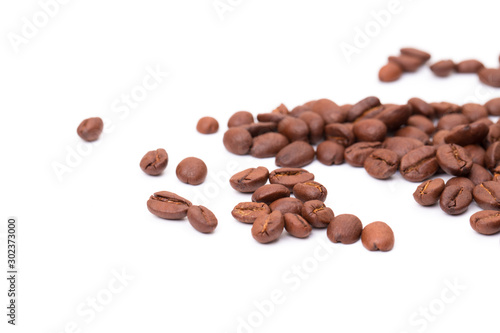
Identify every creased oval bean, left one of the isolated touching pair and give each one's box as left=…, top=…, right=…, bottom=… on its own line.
left=148, top=191, right=192, bottom=220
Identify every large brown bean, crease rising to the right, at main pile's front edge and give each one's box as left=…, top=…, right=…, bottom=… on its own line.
left=399, top=146, right=439, bottom=182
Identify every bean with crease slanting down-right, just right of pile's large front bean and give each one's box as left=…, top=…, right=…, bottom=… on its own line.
left=436, top=143, right=472, bottom=176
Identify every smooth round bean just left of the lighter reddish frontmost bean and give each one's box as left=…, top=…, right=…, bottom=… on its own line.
left=326, top=214, right=363, bottom=244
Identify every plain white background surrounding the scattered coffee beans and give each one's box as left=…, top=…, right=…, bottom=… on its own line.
left=0, top=0, right=500, bottom=333
